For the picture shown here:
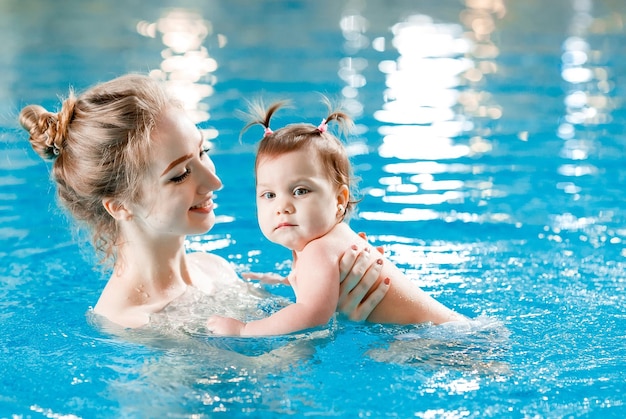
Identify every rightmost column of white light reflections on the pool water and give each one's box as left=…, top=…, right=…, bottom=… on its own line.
left=552, top=0, right=623, bottom=254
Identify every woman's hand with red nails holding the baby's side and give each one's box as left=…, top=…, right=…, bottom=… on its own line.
left=337, top=240, right=389, bottom=321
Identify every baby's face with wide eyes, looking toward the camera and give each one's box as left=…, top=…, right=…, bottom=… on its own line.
left=256, top=148, right=342, bottom=251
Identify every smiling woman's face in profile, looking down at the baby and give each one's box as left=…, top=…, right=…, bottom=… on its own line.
left=131, top=106, right=222, bottom=237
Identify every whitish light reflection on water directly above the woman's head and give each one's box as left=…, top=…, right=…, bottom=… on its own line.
left=137, top=9, right=226, bottom=133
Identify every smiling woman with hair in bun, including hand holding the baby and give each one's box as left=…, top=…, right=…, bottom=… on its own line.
left=20, top=75, right=388, bottom=328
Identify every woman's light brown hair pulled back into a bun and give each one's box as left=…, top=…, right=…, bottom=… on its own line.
left=19, top=75, right=176, bottom=259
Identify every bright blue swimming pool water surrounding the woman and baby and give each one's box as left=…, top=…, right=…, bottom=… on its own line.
left=0, top=0, right=626, bottom=418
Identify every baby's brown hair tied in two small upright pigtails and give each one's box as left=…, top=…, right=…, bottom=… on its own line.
left=243, top=100, right=358, bottom=217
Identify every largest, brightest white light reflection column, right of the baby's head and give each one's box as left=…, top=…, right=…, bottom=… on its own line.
left=368, top=4, right=505, bottom=222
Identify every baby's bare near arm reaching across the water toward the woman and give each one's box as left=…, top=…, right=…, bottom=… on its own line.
left=207, top=243, right=339, bottom=336
